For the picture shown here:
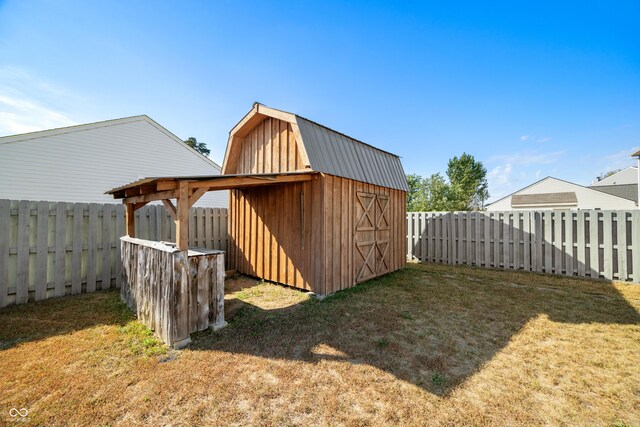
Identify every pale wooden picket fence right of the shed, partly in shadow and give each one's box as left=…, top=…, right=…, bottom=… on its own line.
left=407, top=210, right=640, bottom=282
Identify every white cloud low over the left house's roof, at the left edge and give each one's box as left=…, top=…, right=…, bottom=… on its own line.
left=0, top=66, right=76, bottom=135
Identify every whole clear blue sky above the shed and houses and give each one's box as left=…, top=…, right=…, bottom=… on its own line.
left=0, top=0, right=640, bottom=200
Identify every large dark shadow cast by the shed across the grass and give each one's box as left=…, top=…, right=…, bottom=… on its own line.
left=190, top=265, right=640, bottom=396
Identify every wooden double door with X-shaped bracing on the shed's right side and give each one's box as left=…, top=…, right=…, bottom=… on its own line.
left=354, top=191, right=390, bottom=283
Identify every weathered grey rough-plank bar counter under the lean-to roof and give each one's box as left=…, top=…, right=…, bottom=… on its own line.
left=120, top=236, right=226, bottom=348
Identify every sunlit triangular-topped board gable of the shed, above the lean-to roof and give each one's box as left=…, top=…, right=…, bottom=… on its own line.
left=235, top=117, right=304, bottom=174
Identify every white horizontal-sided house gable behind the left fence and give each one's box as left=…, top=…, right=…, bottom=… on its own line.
left=0, top=116, right=228, bottom=208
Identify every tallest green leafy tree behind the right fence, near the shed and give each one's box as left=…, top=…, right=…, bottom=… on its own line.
left=447, top=153, right=489, bottom=211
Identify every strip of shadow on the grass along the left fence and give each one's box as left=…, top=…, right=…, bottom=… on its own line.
left=0, top=290, right=135, bottom=357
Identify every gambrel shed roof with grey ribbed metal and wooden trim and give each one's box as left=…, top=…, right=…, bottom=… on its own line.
left=222, top=103, right=408, bottom=191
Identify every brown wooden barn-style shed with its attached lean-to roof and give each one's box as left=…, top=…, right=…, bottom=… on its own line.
left=111, top=103, right=407, bottom=295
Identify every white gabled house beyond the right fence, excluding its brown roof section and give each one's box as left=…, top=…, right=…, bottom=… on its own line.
left=487, top=177, right=637, bottom=211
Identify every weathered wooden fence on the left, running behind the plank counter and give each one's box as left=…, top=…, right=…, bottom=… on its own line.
left=0, top=200, right=227, bottom=307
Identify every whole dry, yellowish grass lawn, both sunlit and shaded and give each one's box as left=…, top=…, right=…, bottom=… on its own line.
left=0, top=264, right=640, bottom=426
